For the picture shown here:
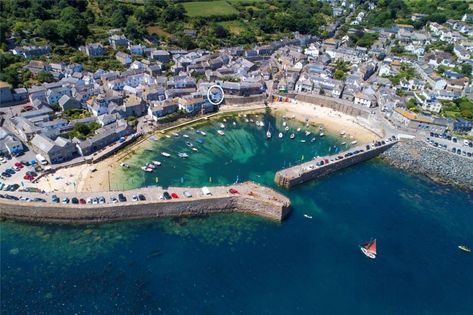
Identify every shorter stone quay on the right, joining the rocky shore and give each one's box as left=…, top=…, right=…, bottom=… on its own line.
left=274, top=136, right=398, bottom=189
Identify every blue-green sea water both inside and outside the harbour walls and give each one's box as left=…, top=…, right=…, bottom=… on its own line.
left=0, top=117, right=473, bottom=314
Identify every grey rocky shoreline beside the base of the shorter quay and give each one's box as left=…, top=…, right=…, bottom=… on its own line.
left=380, top=140, right=473, bottom=191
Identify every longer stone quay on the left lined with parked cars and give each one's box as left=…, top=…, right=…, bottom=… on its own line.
left=0, top=182, right=291, bottom=224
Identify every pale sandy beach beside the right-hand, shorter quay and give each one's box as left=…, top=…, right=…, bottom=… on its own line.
left=270, top=101, right=382, bottom=143
